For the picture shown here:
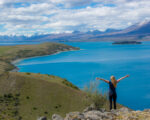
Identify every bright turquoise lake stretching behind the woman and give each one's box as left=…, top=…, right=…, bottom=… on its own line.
left=16, top=42, right=150, bottom=110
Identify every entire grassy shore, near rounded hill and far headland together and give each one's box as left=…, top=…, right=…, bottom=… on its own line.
left=0, top=43, right=84, bottom=120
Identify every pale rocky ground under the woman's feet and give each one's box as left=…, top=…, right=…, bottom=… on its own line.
left=52, top=107, right=150, bottom=120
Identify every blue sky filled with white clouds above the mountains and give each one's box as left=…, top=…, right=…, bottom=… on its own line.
left=0, top=0, right=150, bottom=36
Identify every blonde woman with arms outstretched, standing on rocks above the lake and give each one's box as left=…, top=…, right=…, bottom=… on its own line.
left=96, top=75, right=129, bottom=110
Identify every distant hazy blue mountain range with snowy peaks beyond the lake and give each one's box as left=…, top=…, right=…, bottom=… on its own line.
left=0, top=21, right=150, bottom=42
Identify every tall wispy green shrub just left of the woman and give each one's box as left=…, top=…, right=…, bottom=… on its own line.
left=84, top=81, right=107, bottom=109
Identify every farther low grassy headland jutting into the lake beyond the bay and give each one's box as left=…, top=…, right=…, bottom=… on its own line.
left=0, top=43, right=79, bottom=74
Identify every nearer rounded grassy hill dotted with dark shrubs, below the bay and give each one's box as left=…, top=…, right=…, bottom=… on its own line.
left=0, top=72, right=86, bottom=120
